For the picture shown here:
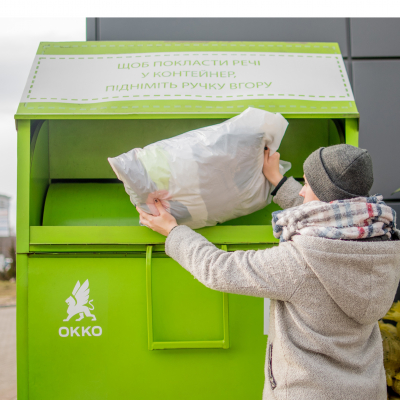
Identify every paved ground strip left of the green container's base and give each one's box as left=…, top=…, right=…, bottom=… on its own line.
left=0, top=301, right=17, bottom=400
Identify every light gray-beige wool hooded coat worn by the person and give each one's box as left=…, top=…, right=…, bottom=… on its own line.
left=165, top=178, right=400, bottom=400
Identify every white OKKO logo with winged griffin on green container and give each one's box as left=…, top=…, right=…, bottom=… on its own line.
left=58, top=279, right=103, bottom=337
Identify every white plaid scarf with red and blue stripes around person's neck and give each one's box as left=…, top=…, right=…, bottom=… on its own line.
left=272, top=195, right=396, bottom=242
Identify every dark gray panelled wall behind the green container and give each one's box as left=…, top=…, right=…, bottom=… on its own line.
left=87, top=18, right=400, bottom=215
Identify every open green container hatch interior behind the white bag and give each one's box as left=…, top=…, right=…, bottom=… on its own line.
left=30, top=119, right=343, bottom=226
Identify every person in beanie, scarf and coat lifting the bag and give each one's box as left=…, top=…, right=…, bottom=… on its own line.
left=138, top=144, right=400, bottom=400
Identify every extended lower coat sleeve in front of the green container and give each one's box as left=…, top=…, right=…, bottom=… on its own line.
left=165, top=225, right=305, bottom=301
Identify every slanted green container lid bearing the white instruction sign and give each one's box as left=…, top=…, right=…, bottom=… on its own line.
left=16, top=41, right=358, bottom=119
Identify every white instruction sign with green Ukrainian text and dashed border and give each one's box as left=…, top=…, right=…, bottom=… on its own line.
left=21, top=52, right=354, bottom=104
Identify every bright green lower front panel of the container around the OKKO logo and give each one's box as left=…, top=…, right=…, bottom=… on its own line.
left=27, top=255, right=267, bottom=400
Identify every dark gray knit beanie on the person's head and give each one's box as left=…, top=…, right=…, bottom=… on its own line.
left=303, top=144, right=374, bottom=202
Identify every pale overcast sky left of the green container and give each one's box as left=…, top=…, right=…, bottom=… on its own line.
left=0, top=17, right=86, bottom=232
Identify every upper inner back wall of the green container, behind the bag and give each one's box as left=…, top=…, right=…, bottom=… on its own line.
left=50, top=119, right=339, bottom=179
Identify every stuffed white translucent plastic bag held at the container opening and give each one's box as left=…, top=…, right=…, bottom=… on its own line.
left=108, top=108, right=291, bottom=229
